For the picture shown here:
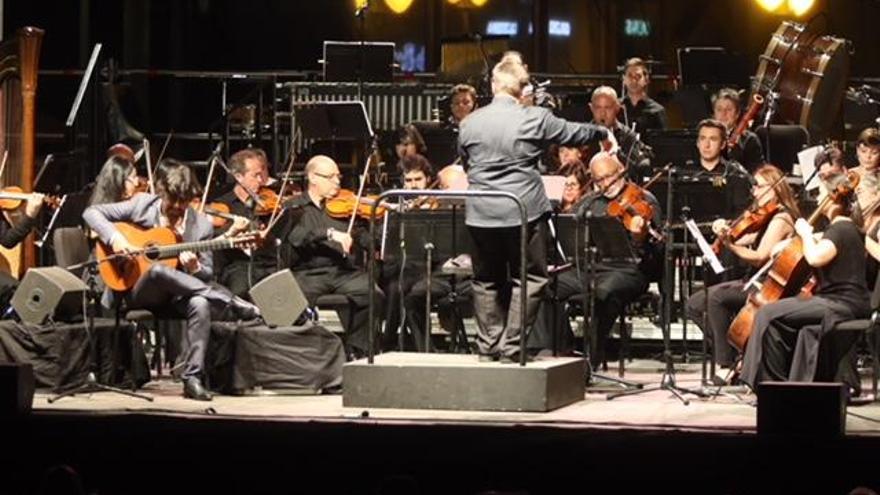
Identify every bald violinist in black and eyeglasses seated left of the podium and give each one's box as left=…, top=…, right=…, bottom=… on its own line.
left=285, top=155, right=383, bottom=357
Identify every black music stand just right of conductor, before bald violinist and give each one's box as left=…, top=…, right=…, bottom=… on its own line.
left=583, top=211, right=643, bottom=389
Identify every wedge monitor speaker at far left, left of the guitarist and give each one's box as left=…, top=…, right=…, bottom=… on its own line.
left=12, top=266, right=88, bottom=325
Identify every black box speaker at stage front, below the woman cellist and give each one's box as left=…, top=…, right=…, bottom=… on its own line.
left=758, top=382, right=846, bottom=438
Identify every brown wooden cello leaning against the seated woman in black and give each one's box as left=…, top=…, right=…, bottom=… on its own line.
left=727, top=173, right=859, bottom=352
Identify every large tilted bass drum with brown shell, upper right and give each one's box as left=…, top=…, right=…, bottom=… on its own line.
left=752, top=21, right=849, bottom=143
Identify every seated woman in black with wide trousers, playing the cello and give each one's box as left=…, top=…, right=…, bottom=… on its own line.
left=742, top=169, right=870, bottom=390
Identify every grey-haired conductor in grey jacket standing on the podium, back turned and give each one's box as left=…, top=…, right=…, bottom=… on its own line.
left=458, top=58, right=615, bottom=362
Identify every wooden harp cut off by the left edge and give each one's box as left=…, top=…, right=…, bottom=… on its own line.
left=0, top=27, right=43, bottom=277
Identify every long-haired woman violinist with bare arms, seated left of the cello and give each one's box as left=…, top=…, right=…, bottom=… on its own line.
left=686, top=164, right=800, bottom=378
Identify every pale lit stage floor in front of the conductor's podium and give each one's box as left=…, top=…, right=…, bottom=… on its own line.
left=33, top=359, right=880, bottom=436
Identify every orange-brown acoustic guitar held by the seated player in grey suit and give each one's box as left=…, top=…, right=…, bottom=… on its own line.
left=95, top=222, right=262, bottom=292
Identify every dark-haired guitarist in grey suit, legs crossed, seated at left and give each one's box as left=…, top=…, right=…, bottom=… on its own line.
left=83, top=159, right=259, bottom=401
